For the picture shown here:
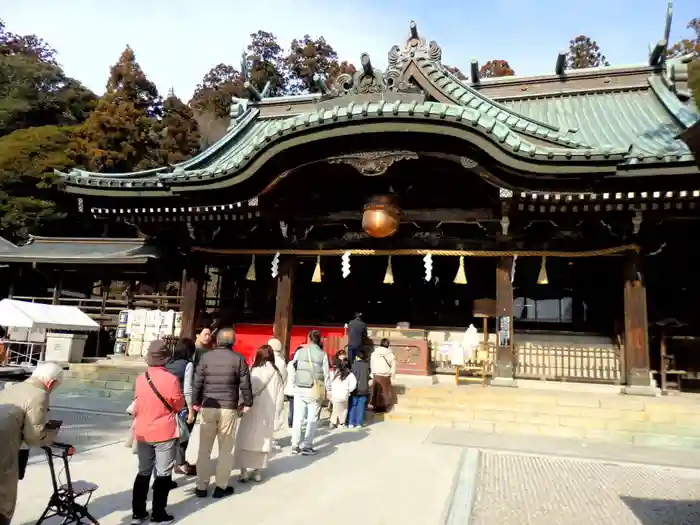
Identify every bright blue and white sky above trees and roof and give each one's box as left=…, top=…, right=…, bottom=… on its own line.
left=0, top=0, right=700, bottom=100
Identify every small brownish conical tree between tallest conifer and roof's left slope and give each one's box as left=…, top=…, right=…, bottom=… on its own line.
left=159, top=90, right=200, bottom=164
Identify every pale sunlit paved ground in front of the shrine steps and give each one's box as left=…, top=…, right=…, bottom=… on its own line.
left=13, top=409, right=700, bottom=525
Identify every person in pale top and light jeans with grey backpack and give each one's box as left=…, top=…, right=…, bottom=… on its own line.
left=292, top=330, right=330, bottom=456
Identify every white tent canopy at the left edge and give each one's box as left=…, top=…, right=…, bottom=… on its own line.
left=0, top=299, right=100, bottom=332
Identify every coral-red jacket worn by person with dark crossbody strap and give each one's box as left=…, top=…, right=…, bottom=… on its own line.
left=134, top=366, right=185, bottom=443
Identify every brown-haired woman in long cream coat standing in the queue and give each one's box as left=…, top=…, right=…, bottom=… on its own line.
left=233, top=345, right=284, bottom=482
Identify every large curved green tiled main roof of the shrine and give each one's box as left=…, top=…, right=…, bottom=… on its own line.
left=61, top=20, right=699, bottom=195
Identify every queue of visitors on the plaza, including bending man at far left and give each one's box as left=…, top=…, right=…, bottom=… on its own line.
left=0, top=320, right=396, bottom=525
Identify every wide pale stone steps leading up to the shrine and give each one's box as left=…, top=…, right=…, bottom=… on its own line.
left=384, top=385, right=700, bottom=449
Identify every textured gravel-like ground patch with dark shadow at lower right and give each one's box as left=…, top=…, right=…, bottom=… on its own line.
left=472, top=453, right=700, bottom=525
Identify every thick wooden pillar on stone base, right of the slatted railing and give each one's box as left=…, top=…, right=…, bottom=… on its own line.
left=624, top=254, right=657, bottom=395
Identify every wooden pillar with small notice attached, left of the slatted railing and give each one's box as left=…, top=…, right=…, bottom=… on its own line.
left=491, top=257, right=515, bottom=386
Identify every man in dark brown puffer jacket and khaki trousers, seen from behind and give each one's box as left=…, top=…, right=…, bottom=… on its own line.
left=192, top=328, right=253, bottom=498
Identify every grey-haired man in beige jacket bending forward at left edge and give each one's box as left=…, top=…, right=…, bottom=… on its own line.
left=0, top=363, right=63, bottom=525
